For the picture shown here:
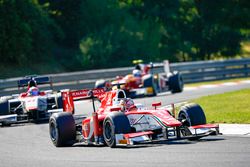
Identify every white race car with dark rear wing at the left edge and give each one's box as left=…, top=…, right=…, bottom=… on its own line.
left=0, top=76, right=62, bottom=125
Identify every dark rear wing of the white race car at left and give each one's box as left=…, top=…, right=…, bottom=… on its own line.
left=17, top=76, right=52, bottom=88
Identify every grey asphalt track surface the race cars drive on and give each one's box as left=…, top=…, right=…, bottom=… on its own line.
left=0, top=83, right=250, bottom=167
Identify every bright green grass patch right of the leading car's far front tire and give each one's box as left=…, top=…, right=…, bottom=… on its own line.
left=192, top=89, right=250, bottom=124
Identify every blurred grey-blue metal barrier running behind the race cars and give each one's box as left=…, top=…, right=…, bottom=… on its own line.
left=0, top=58, right=250, bottom=95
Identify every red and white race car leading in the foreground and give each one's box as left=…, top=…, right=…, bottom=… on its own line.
left=49, top=89, right=219, bottom=147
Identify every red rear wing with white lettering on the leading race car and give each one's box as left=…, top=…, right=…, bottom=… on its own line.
left=62, top=88, right=105, bottom=114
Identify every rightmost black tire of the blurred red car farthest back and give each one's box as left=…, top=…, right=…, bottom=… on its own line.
left=168, top=71, right=184, bottom=93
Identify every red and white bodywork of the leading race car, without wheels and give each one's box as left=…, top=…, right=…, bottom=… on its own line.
left=62, top=88, right=184, bottom=140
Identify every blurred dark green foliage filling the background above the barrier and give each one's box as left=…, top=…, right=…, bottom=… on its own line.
left=0, top=0, right=250, bottom=78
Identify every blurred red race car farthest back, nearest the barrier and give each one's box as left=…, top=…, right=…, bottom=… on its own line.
left=95, top=61, right=184, bottom=98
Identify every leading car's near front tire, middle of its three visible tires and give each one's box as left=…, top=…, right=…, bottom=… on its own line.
left=103, top=112, right=131, bottom=148
